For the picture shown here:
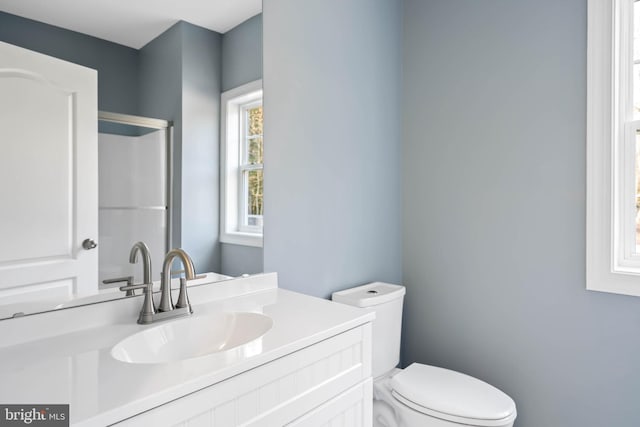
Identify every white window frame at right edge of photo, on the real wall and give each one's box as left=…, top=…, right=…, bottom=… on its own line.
left=586, top=0, right=640, bottom=296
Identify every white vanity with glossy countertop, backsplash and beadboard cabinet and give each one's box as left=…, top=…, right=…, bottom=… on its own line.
left=0, top=273, right=373, bottom=427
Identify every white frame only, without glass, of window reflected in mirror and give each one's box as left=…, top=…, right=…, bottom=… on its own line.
left=220, top=80, right=263, bottom=247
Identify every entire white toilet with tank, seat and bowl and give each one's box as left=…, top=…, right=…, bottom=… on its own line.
left=332, top=282, right=516, bottom=427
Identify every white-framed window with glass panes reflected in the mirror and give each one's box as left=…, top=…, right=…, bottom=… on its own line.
left=220, top=80, right=264, bottom=247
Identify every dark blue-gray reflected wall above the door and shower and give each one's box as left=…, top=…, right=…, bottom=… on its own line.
left=0, top=12, right=139, bottom=114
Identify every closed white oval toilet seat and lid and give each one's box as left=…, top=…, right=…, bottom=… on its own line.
left=391, top=363, right=516, bottom=427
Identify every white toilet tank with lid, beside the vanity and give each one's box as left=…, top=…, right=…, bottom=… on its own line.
left=331, top=282, right=405, bottom=378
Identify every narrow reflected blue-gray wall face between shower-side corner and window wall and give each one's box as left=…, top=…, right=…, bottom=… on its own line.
left=181, top=22, right=222, bottom=271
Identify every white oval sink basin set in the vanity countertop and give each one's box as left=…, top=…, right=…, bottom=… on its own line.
left=111, top=312, right=273, bottom=363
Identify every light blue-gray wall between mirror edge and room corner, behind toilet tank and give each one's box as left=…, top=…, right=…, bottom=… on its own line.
left=263, top=0, right=401, bottom=297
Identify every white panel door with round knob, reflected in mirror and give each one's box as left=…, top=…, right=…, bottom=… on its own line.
left=0, top=42, right=98, bottom=300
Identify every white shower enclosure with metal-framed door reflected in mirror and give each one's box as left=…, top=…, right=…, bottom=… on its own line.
left=98, top=112, right=172, bottom=288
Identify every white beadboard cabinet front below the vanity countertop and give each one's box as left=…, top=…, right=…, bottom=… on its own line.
left=115, top=323, right=372, bottom=427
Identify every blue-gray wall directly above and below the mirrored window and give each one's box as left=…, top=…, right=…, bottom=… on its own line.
left=220, top=14, right=263, bottom=276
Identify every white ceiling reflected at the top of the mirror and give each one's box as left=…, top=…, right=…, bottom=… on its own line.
left=0, top=0, right=262, bottom=49
